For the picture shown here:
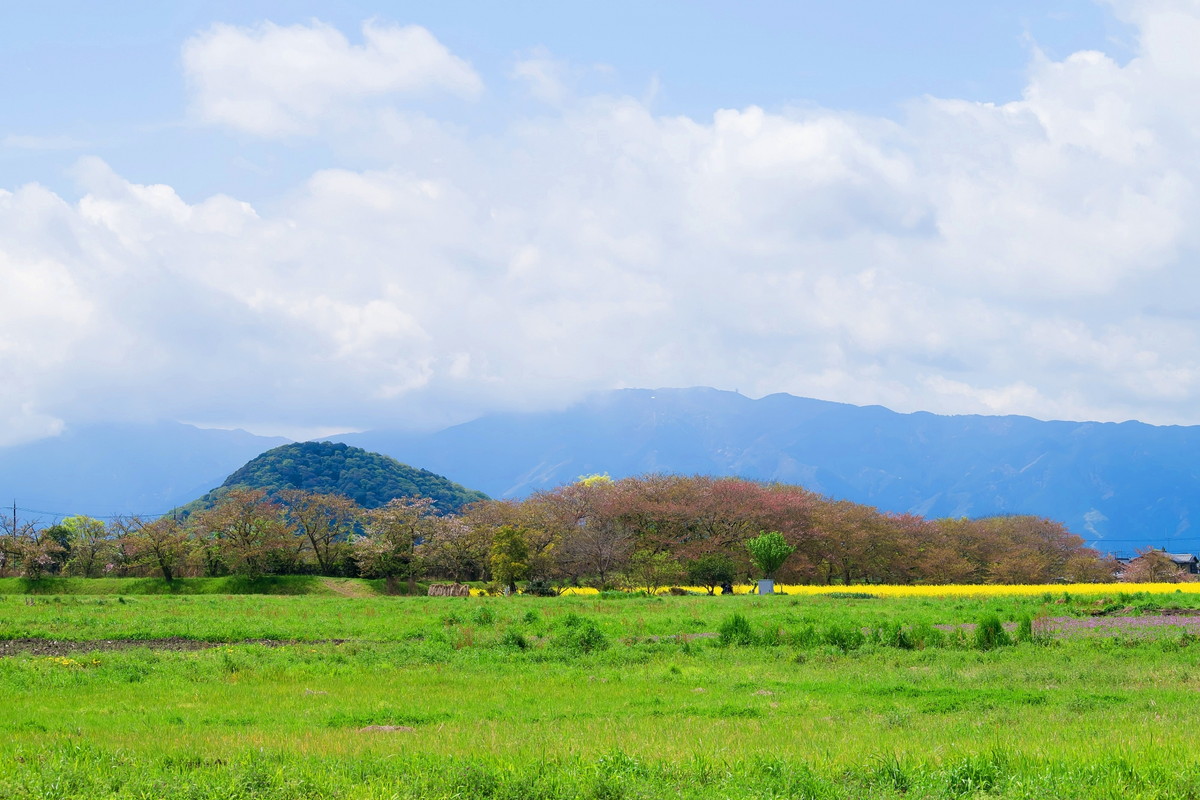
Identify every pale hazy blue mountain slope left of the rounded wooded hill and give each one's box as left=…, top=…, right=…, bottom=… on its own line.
left=0, top=422, right=287, bottom=517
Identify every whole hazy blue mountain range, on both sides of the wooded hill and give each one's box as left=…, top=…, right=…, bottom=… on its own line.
left=0, top=389, right=1200, bottom=553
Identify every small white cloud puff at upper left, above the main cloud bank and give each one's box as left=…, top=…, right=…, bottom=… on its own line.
left=184, top=22, right=482, bottom=137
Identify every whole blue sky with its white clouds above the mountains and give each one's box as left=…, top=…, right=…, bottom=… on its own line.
left=7, top=0, right=1200, bottom=445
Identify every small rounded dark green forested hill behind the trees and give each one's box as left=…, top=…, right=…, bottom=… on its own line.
left=190, top=441, right=487, bottom=513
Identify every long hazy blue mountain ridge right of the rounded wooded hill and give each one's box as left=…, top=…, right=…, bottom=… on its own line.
left=337, top=389, right=1200, bottom=552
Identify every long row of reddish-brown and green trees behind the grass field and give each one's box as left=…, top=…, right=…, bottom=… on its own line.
left=0, top=475, right=1132, bottom=593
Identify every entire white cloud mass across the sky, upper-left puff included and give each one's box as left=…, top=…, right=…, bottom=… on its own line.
left=0, top=1, right=1200, bottom=439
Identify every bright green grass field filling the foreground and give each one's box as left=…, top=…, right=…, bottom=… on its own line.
left=0, top=584, right=1200, bottom=799
